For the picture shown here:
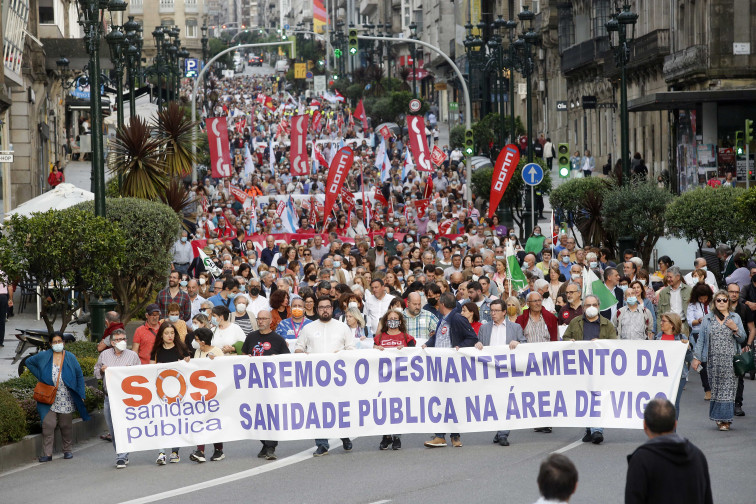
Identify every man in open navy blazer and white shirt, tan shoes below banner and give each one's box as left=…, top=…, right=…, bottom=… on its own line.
left=423, top=292, right=478, bottom=448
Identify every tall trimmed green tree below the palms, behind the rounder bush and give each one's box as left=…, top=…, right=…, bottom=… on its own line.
left=77, top=198, right=181, bottom=324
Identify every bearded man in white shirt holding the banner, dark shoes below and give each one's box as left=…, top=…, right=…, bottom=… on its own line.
left=295, top=297, right=355, bottom=457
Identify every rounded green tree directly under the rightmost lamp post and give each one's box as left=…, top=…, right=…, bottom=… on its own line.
left=603, top=183, right=672, bottom=264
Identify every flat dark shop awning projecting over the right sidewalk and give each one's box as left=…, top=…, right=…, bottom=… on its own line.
left=627, top=89, right=756, bottom=112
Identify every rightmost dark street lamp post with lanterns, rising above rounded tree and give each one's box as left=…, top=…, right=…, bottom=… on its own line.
left=606, top=3, right=638, bottom=183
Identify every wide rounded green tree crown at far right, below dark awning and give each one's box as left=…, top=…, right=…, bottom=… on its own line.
left=666, top=186, right=753, bottom=248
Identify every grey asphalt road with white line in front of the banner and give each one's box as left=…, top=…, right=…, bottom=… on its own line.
left=0, top=373, right=756, bottom=504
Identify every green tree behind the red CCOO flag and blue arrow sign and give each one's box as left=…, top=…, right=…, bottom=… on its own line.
left=471, top=159, right=551, bottom=240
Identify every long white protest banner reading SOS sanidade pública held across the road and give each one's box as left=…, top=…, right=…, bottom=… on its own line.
left=106, top=340, right=686, bottom=452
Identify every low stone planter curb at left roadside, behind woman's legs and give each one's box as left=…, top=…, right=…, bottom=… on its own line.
left=0, top=411, right=107, bottom=474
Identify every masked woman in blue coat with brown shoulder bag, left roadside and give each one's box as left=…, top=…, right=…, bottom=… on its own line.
left=26, top=331, right=89, bottom=462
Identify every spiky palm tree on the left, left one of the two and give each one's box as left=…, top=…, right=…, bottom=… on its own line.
left=108, top=116, right=168, bottom=200
